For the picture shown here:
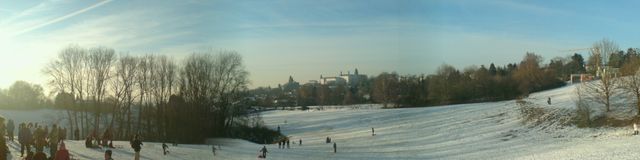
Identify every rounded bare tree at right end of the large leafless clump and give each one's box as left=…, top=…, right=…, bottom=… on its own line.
left=180, top=51, right=249, bottom=137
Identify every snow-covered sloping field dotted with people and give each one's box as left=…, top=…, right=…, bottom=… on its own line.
left=0, top=85, right=640, bottom=160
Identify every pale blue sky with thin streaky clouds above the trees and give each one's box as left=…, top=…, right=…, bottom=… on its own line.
left=0, top=0, right=640, bottom=91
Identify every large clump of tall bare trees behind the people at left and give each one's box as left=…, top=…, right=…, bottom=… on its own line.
left=44, top=45, right=248, bottom=143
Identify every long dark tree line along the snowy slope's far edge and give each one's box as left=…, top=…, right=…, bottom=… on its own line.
left=250, top=52, right=596, bottom=107
